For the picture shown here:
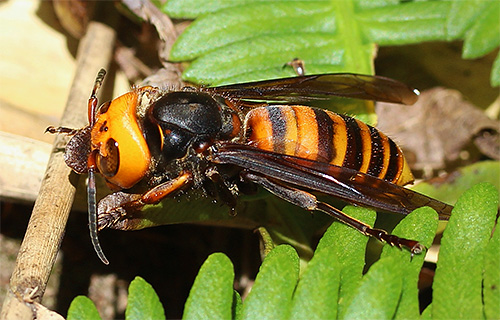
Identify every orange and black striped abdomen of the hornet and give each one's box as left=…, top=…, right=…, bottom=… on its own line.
left=245, top=106, right=413, bottom=185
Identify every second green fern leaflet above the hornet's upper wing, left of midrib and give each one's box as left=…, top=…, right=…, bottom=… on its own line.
left=171, top=2, right=335, bottom=62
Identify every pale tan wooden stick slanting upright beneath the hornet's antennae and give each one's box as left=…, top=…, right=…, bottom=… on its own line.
left=0, top=22, right=116, bottom=319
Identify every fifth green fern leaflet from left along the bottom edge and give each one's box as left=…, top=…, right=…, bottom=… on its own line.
left=290, top=244, right=340, bottom=320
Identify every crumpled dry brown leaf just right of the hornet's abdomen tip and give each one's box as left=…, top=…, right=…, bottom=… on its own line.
left=377, top=88, right=500, bottom=170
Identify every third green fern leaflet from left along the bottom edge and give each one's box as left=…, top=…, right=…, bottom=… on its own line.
left=183, top=253, right=235, bottom=319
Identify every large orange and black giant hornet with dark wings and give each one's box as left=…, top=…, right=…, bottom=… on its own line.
left=47, top=70, right=453, bottom=264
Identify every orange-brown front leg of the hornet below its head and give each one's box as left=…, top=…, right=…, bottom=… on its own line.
left=97, top=172, right=193, bottom=230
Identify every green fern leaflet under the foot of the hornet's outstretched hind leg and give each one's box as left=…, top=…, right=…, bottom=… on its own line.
left=345, top=208, right=438, bottom=319
